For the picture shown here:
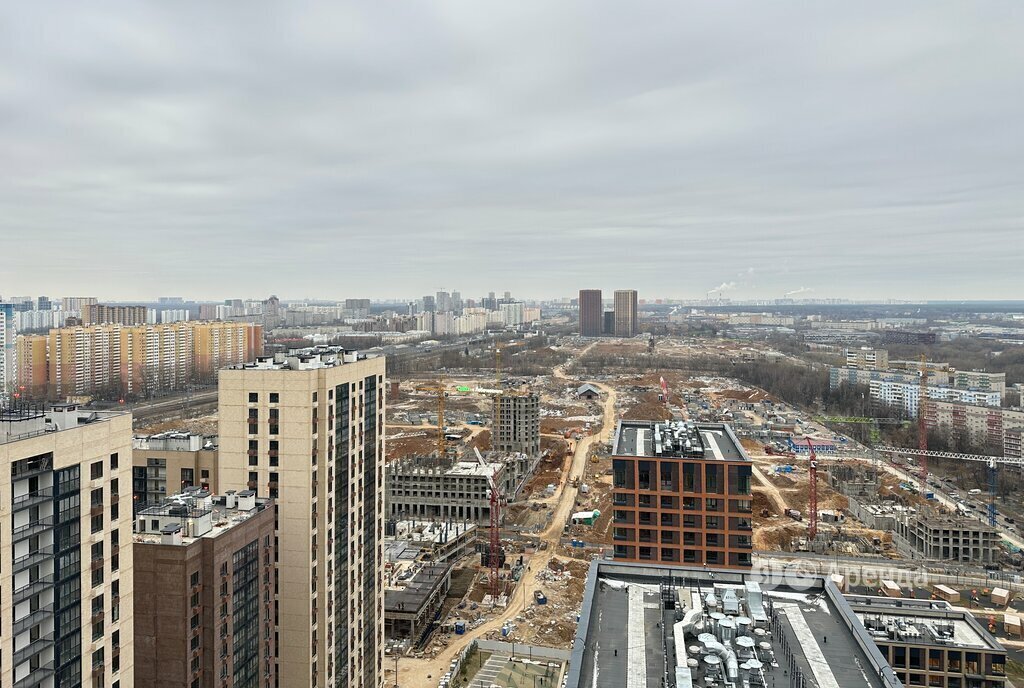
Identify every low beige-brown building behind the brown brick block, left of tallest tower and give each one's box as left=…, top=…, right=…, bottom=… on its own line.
left=131, top=432, right=220, bottom=510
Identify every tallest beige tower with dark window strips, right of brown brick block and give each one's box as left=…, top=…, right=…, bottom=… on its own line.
left=218, top=348, right=385, bottom=688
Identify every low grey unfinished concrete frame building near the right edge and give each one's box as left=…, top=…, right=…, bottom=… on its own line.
left=893, top=509, right=999, bottom=564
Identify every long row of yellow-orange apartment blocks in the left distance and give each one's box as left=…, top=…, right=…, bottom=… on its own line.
left=17, top=321, right=263, bottom=399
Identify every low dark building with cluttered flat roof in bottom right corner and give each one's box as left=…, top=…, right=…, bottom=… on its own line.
left=847, top=596, right=1007, bottom=688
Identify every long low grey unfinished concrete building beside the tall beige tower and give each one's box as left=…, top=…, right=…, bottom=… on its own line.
left=384, top=454, right=537, bottom=523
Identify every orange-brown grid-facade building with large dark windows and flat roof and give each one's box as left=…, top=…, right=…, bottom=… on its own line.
left=611, top=421, right=753, bottom=568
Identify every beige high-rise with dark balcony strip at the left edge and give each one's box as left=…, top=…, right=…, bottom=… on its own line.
left=0, top=404, right=134, bottom=688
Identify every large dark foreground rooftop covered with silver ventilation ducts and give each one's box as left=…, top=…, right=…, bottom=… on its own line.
left=565, top=560, right=901, bottom=688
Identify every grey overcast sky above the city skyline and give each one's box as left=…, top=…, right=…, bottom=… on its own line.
left=0, top=0, right=1024, bottom=299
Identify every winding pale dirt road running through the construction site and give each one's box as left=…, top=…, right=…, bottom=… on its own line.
left=384, top=344, right=615, bottom=688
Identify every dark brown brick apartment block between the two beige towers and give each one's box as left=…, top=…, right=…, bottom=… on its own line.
left=133, top=488, right=278, bottom=688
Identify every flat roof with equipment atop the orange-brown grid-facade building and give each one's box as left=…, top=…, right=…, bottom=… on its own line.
left=611, top=421, right=750, bottom=461
